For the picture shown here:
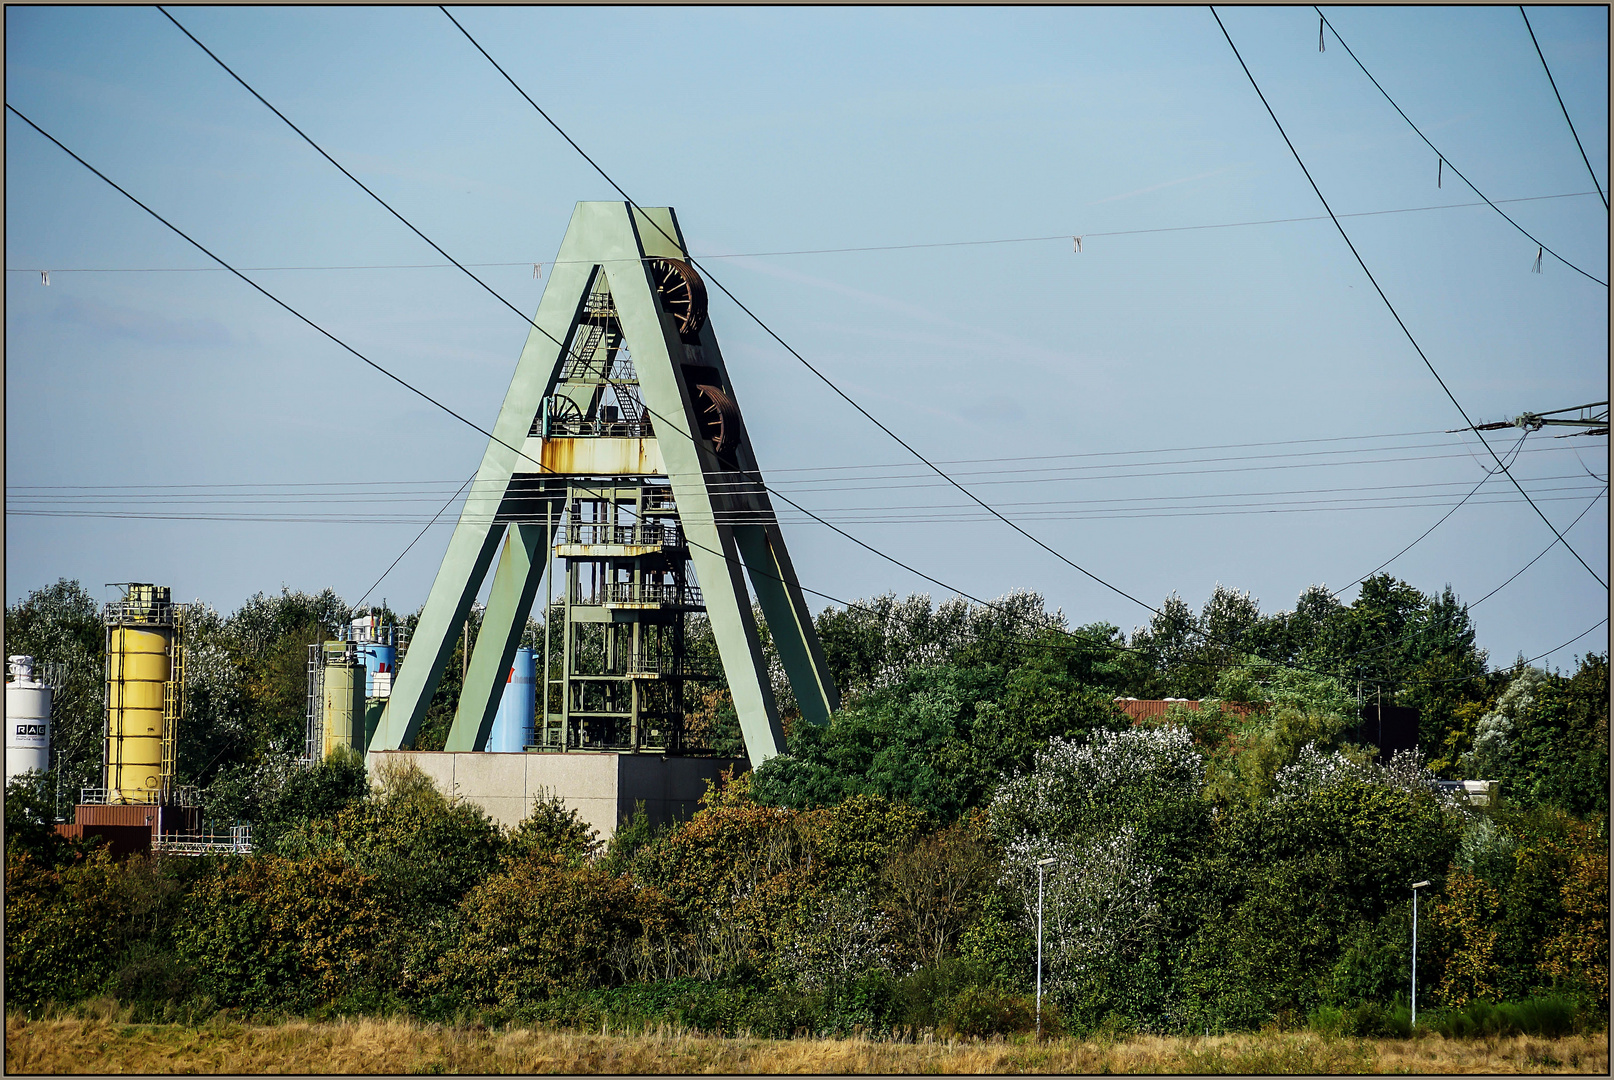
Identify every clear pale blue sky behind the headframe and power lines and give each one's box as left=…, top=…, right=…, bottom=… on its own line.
left=6, top=6, right=1609, bottom=663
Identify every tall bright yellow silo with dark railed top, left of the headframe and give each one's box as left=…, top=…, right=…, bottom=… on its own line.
left=103, top=584, right=184, bottom=802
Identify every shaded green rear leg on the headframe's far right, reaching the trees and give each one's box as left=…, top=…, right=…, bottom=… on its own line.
left=734, top=525, right=841, bottom=725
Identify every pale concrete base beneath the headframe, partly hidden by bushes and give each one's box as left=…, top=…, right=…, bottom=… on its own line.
left=370, top=751, right=751, bottom=841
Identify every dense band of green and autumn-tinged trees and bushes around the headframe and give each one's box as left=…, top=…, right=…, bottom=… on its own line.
left=5, top=578, right=1609, bottom=1046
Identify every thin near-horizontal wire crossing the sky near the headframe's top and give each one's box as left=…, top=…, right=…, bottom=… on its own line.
left=6, top=189, right=1603, bottom=274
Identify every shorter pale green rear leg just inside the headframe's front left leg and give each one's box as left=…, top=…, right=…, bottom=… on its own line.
left=444, top=521, right=550, bottom=752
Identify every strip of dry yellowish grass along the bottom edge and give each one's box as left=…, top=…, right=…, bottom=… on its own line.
left=5, top=1003, right=1609, bottom=1075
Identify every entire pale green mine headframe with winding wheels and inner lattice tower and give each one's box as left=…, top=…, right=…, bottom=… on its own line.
left=368, top=202, right=839, bottom=765
